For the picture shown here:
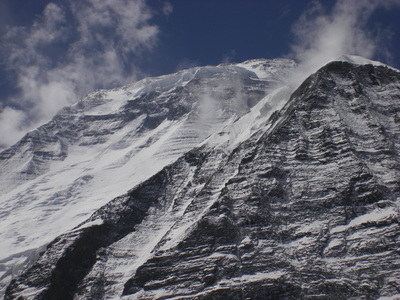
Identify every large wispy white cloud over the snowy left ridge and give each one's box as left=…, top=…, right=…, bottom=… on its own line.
left=0, top=0, right=164, bottom=148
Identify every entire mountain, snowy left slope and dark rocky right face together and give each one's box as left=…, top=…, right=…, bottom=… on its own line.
left=1, top=56, right=400, bottom=299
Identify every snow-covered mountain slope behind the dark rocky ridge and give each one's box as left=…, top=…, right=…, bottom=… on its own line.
left=0, top=59, right=295, bottom=292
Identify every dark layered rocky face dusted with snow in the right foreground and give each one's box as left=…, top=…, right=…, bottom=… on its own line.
left=5, top=58, right=400, bottom=299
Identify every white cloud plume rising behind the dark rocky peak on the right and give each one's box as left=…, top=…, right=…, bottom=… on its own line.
left=290, top=0, right=400, bottom=84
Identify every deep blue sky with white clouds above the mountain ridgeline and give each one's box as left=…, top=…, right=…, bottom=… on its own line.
left=0, top=0, right=400, bottom=149
